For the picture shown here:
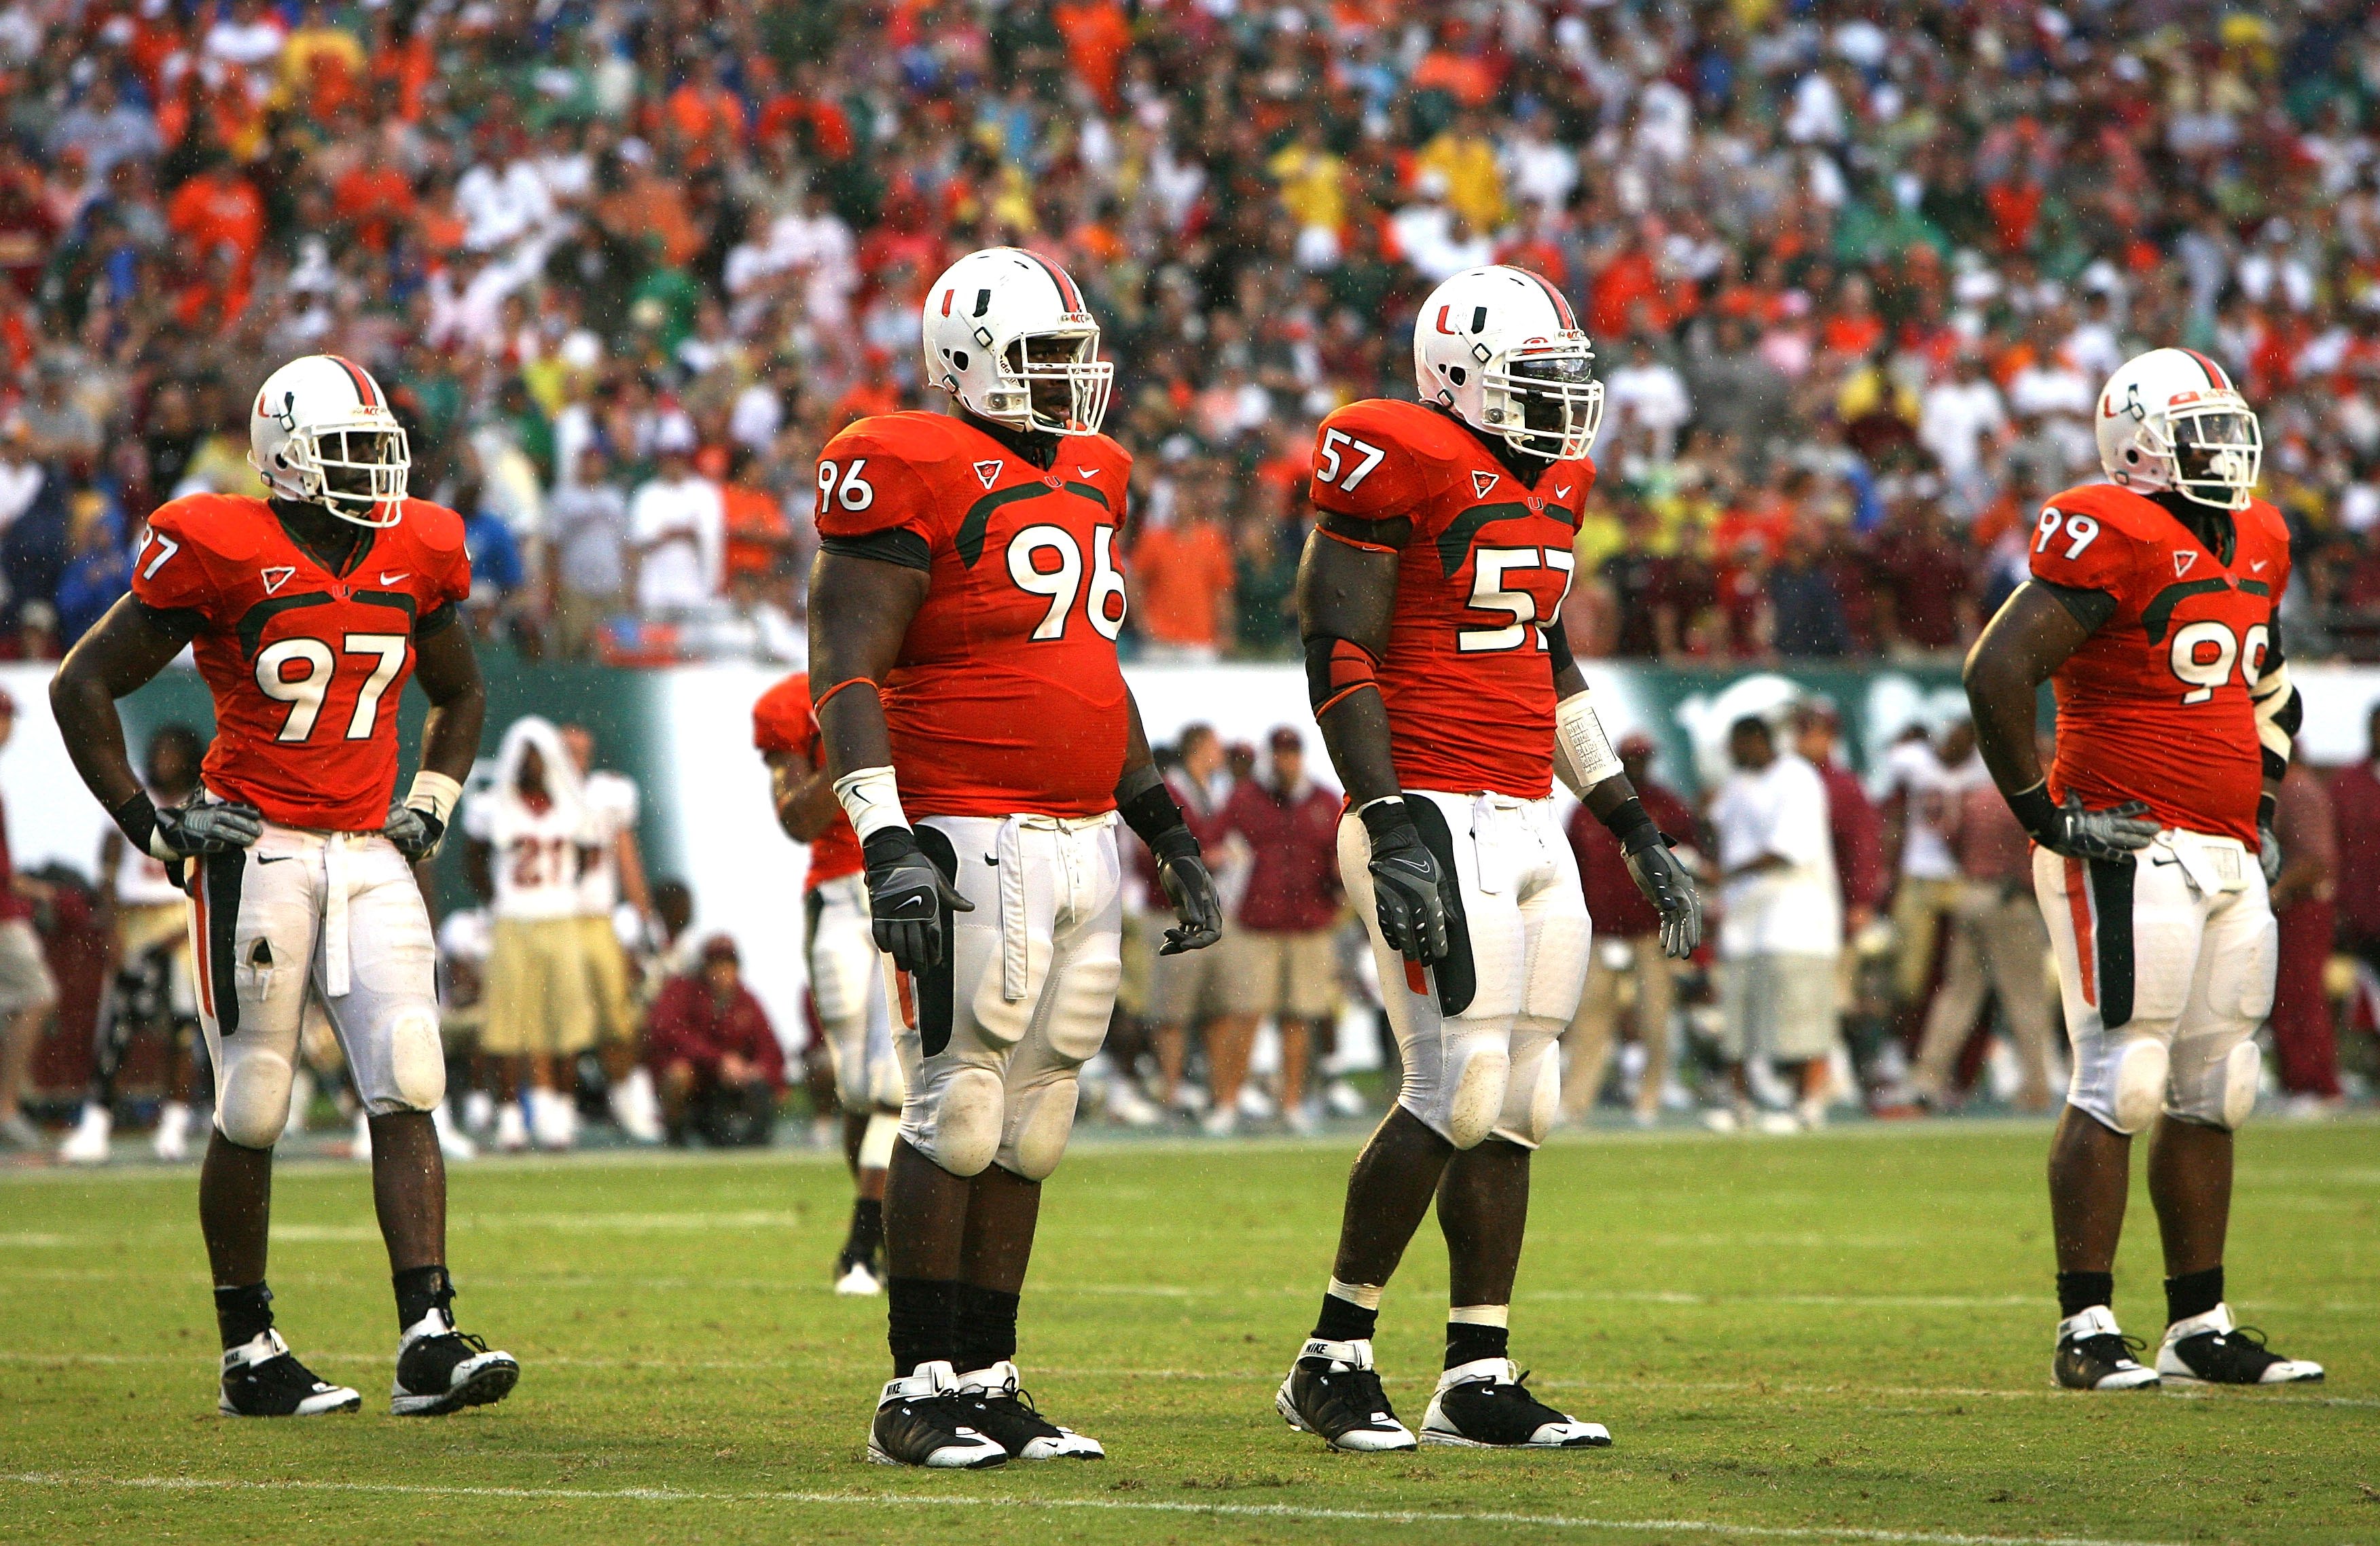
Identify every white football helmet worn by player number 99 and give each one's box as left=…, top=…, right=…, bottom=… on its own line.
left=2097, top=350, right=2263, bottom=509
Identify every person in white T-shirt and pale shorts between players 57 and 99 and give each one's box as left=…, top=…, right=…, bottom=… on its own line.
left=1709, top=713, right=1842, bottom=1132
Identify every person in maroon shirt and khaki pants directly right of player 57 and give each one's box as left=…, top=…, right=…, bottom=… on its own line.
left=1562, top=730, right=1701, bottom=1125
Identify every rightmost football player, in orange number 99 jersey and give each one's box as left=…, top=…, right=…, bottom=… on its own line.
left=1966, top=350, right=2323, bottom=1391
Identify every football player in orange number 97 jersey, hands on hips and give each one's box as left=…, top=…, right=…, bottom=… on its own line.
left=50, top=355, right=521, bottom=1418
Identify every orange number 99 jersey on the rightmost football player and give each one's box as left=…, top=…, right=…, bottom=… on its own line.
left=2032, top=483, right=2290, bottom=847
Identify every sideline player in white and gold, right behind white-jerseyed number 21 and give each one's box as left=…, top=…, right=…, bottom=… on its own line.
left=562, top=725, right=662, bottom=1144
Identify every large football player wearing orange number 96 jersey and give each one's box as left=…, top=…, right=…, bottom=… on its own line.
left=809, top=247, right=1223, bottom=1467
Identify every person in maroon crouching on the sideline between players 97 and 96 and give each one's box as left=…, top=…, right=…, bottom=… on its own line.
left=645, top=935, right=785, bottom=1149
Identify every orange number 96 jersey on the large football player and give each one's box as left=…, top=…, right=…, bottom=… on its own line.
left=818, top=414, right=1133, bottom=816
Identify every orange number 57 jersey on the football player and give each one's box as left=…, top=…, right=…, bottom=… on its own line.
left=1314, top=399, right=1595, bottom=799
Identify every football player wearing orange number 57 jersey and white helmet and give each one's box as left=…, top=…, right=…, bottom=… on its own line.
left=1274, top=266, right=1701, bottom=1451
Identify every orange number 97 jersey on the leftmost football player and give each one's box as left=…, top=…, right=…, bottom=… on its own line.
left=133, top=495, right=471, bottom=833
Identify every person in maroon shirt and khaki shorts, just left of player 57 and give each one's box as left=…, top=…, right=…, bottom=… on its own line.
left=1207, top=725, right=1345, bottom=1132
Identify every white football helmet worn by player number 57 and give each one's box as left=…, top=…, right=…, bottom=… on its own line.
left=1413, top=264, right=1604, bottom=456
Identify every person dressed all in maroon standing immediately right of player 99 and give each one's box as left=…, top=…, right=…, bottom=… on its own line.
left=2271, top=754, right=2339, bottom=1109
